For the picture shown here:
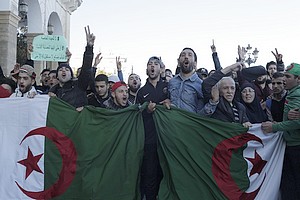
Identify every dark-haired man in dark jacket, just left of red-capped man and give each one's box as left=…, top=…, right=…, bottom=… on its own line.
left=88, top=74, right=110, bottom=108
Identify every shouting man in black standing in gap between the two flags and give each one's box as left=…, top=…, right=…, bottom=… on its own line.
left=135, top=57, right=168, bottom=200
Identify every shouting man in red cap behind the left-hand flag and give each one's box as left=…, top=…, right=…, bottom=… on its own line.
left=103, top=81, right=131, bottom=110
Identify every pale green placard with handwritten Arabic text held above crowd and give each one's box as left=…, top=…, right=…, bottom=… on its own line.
left=31, top=35, right=67, bottom=62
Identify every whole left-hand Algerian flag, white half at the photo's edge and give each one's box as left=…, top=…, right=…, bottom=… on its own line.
left=0, top=95, right=144, bottom=200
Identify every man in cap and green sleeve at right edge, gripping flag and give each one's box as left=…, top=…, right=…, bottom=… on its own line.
left=261, top=63, right=300, bottom=199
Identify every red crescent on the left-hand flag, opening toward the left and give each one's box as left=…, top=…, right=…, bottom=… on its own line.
left=16, top=127, right=77, bottom=199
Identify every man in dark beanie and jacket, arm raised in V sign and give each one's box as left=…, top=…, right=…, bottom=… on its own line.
left=48, top=27, right=95, bottom=111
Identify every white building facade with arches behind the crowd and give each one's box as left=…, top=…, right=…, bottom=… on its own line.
left=0, top=0, right=82, bottom=75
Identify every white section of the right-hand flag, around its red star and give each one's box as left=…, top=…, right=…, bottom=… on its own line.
left=243, top=124, right=285, bottom=200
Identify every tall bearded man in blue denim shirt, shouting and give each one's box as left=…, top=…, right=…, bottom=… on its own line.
left=168, top=48, right=218, bottom=115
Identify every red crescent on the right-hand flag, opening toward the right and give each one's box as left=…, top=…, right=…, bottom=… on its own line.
left=212, top=133, right=262, bottom=200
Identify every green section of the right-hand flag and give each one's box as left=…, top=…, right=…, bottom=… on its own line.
left=154, top=106, right=249, bottom=200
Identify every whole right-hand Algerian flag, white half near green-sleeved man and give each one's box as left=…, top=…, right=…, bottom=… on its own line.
left=154, top=107, right=285, bottom=200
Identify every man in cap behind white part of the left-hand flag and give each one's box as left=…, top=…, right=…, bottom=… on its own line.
left=10, top=65, right=38, bottom=98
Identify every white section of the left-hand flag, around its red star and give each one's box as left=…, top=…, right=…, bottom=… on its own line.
left=0, top=95, right=49, bottom=199
